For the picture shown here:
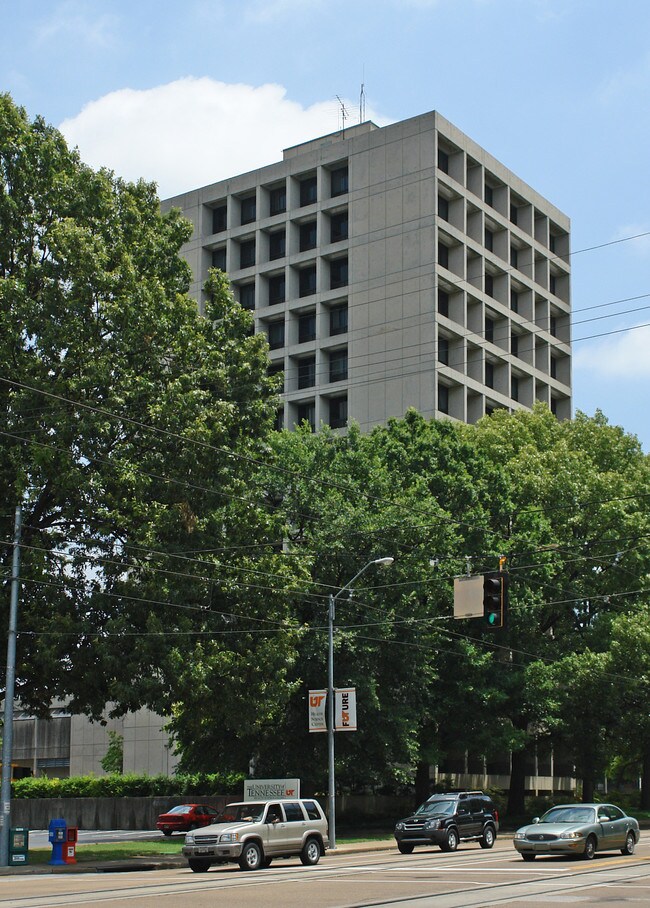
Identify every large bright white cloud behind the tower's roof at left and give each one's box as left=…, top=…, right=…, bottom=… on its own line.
left=60, top=77, right=388, bottom=198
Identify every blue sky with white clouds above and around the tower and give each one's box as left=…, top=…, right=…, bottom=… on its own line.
left=0, top=0, right=650, bottom=452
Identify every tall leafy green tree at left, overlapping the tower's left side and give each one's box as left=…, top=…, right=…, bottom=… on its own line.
left=0, top=95, right=294, bottom=744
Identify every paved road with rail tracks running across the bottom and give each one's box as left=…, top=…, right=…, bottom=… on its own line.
left=5, top=839, right=650, bottom=908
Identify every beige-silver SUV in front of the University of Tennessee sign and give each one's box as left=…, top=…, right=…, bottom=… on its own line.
left=183, top=798, right=329, bottom=873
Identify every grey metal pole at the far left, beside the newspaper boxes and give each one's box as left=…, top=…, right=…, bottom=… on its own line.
left=0, top=505, right=22, bottom=867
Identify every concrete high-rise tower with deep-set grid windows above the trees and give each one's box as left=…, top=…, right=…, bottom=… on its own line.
left=163, top=112, right=571, bottom=430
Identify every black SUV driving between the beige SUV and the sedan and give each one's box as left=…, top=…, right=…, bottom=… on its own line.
left=395, top=791, right=499, bottom=854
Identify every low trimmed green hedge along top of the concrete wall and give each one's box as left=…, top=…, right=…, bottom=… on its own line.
left=11, top=773, right=244, bottom=798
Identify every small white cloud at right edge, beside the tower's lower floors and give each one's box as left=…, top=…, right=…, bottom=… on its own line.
left=573, top=324, right=650, bottom=379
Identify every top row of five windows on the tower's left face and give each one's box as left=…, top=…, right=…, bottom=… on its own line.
left=211, top=164, right=348, bottom=233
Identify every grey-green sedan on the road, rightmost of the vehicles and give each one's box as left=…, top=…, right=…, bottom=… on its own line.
left=513, top=804, right=639, bottom=861
